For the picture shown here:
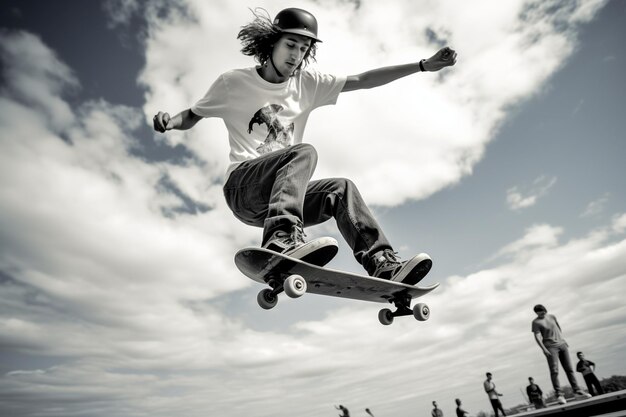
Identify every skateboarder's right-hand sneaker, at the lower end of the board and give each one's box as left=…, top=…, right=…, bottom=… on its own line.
left=370, top=249, right=433, bottom=285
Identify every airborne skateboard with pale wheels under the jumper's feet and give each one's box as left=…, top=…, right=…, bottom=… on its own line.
left=235, top=247, right=439, bottom=325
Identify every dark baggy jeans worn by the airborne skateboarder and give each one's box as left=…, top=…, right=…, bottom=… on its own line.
left=224, top=143, right=391, bottom=269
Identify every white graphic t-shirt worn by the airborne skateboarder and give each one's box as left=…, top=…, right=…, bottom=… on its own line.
left=191, top=67, right=346, bottom=179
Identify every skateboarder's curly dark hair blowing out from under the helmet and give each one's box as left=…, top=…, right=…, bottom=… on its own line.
left=237, top=8, right=317, bottom=67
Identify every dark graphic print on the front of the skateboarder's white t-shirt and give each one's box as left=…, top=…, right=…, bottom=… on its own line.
left=248, top=104, right=293, bottom=155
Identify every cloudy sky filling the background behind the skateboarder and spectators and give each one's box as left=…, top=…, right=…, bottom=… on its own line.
left=0, top=0, right=626, bottom=417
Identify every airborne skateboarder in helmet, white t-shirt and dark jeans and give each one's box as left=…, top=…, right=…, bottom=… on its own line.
left=153, top=8, right=456, bottom=284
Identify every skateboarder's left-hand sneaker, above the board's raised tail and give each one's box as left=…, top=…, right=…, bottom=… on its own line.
left=263, top=225, right=339, bottom=266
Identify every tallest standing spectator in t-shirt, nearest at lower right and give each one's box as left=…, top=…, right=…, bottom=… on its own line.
left=532, top=304, right=590, bottom=404
